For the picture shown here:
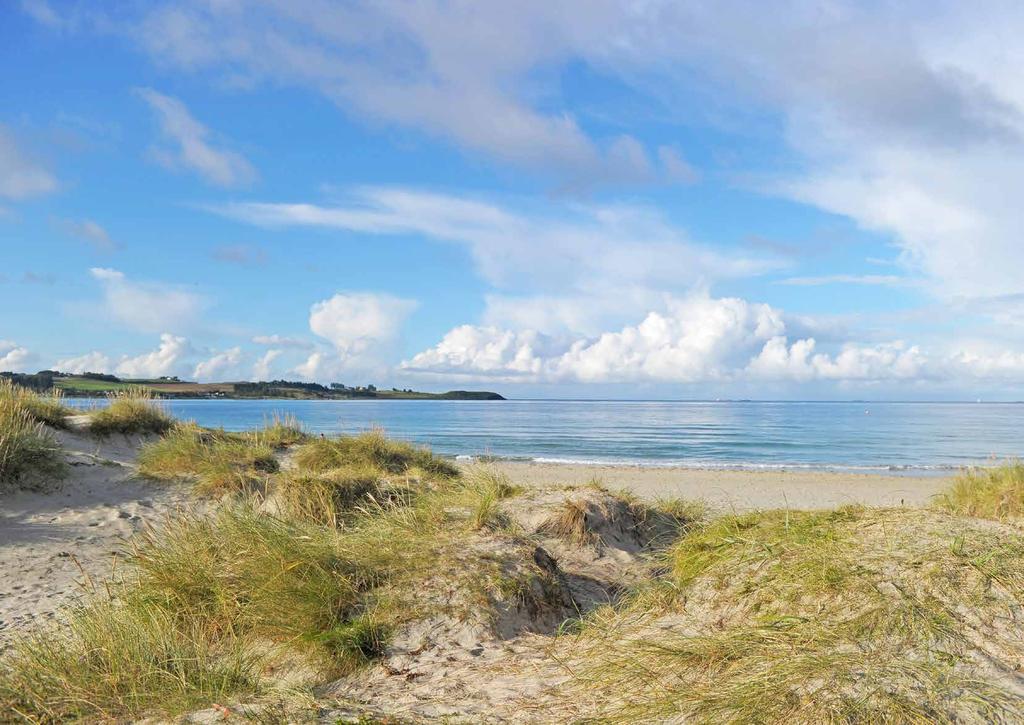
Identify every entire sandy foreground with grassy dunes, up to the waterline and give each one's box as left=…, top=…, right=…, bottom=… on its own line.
left=0, top=388, right=1024, bottom=724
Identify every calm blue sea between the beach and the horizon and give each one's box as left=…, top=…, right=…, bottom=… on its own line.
left=66, top=400, right=1024, bottom=475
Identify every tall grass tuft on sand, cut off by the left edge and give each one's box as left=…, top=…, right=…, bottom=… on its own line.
left=0, top=396, right=66, bottom=488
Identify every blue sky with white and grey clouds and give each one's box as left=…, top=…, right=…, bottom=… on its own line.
left=0, top=0, right=1024, bottom=400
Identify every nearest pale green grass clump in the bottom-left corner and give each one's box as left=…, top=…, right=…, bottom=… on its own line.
left=0, top=591, right=259, bottom=723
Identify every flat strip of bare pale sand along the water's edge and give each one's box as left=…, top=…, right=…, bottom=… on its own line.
left=488, top=461, right=954, bottom=511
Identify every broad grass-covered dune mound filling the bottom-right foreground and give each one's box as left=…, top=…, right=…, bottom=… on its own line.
left=572, top=507, right=1024, bottom=723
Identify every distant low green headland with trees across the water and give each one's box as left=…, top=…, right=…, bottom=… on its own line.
left=0, top=370, right=505, bottom=400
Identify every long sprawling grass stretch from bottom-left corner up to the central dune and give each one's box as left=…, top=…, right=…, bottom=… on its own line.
left=0, top=460, right=544, bottom=721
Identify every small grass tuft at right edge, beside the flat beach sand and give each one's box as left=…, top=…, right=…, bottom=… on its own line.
left=936, top=462, right=1024, bottom=521
